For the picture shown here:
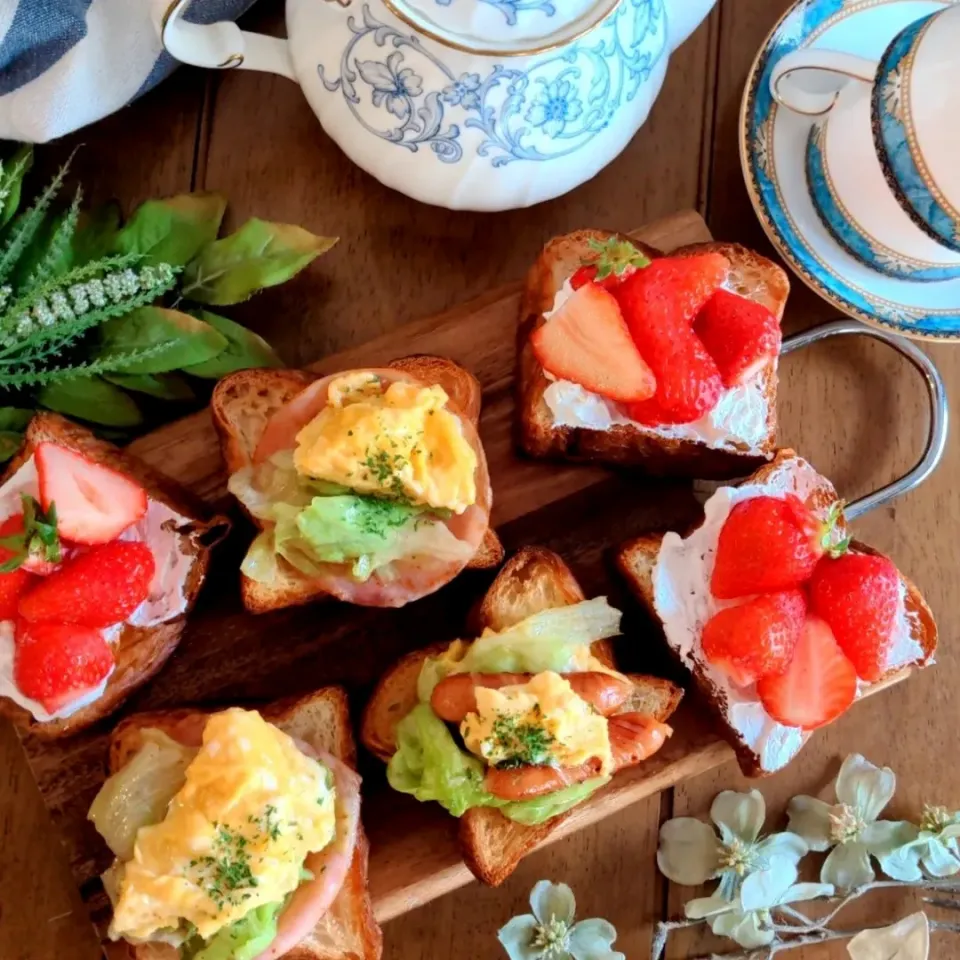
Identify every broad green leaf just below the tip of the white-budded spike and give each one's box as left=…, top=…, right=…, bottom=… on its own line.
left=99, top=307, right=227, bottom=373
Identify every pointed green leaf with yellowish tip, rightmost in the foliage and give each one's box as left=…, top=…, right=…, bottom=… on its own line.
left=183, top=217, right=337, bottom=306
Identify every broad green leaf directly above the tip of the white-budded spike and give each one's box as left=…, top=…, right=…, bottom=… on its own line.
left=114, top=193, right=227, bottom=267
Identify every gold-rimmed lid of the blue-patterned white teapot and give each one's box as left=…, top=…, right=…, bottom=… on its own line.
left=384, top=0, right=622, bottom=56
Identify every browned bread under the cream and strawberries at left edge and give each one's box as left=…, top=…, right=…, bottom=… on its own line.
left=0, top=413, right=230, bottom=739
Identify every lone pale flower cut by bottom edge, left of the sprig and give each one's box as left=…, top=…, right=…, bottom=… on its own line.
left=497, top=880, right=626, bottom=960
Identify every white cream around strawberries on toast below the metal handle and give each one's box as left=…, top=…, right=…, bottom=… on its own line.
left=653, top=457, right=923, bottom=772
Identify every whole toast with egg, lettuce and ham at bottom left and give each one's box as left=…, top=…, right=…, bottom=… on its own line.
left=90, top=687, right=381, bottom=960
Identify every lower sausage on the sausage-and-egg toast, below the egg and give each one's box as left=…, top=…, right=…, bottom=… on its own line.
left=484, top=713, right=673, bottom=800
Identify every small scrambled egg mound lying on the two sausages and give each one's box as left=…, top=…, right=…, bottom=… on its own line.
left=460, top=671, right=613, bottom=774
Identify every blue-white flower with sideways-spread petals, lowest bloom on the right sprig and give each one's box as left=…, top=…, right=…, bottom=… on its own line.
left=684, top=856, right=834, bottom=950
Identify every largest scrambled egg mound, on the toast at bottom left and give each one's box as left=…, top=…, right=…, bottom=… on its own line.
left=110, top=709, right=335, bottom=941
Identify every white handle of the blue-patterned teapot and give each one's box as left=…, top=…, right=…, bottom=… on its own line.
left=153, top=0, right=296, bottom=82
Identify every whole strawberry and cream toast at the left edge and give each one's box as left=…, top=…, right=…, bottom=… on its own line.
left=0, top=413, right=226, bottom=737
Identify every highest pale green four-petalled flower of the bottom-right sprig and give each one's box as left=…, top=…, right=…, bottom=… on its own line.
left=787, top=753, right=917, bottom=890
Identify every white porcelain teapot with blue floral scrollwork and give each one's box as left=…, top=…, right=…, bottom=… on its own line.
left=156, top=0, right=716, bottom=210
